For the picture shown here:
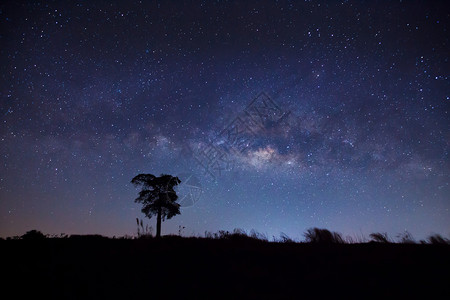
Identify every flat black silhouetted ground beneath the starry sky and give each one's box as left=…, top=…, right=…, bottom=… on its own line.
left=0, top=236, right=450, bottom=299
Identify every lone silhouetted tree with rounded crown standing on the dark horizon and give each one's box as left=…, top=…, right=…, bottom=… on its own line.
left=131, top=174, right=181, bottom=237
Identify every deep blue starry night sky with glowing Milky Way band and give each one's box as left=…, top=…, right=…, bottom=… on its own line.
left=0, top=1, right=450, bottom=239
